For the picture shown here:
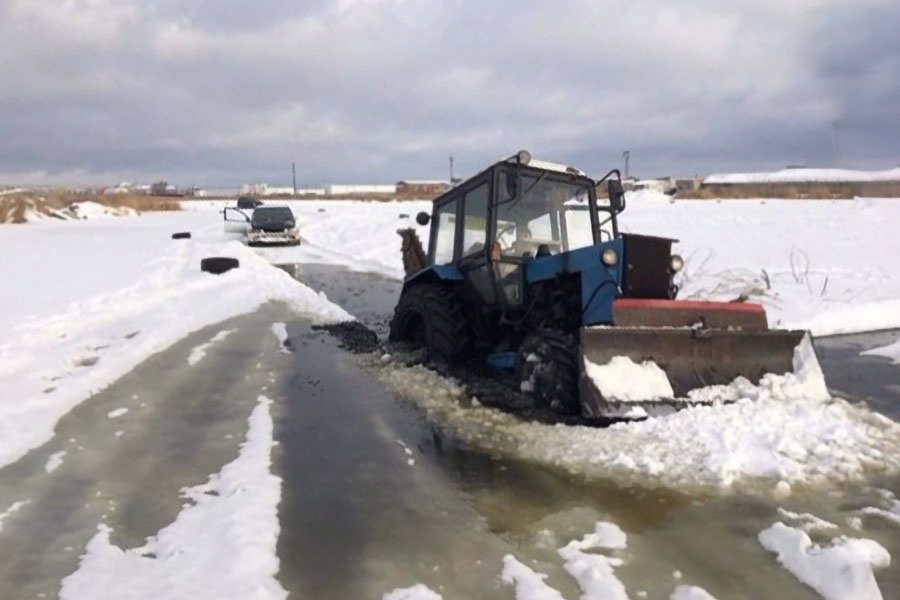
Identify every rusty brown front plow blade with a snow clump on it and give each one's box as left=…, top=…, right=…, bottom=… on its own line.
left=579, top=326, right=807, bottom=419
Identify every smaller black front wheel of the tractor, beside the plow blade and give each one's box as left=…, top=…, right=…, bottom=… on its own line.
left=516, top=329, right=581, bottom=415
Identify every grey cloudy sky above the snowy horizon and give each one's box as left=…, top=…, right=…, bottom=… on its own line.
left=0, top=0, right=900, bottom=185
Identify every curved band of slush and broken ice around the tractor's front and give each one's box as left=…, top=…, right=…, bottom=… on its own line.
left=372, top=348, right=900, bottom=493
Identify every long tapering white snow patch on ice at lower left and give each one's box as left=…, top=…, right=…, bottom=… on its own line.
left=59, top=396, right=287, bottom=600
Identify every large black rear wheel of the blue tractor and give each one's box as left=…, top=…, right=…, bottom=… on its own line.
left=388, top=283, right=469, bottom=365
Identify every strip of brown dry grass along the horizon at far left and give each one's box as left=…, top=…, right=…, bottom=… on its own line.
left=0, top=191, right=181, bottom=223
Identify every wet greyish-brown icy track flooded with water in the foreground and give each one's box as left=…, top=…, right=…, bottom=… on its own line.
left=0, top=274, right=900, bottom=600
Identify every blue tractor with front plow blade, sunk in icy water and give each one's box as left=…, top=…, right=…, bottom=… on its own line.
left=390, top=150, right=806, bottom=418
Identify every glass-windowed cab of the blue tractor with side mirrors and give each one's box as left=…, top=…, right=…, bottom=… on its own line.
left=419, top=151, right=624, bottom=311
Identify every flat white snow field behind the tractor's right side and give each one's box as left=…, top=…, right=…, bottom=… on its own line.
left=620, top=193, right=900, bottom=335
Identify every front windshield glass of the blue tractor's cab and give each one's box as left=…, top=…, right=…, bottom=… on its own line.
left=494, top=171, right=594, bottom=257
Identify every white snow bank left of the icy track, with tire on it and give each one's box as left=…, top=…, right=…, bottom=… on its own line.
left=0, top=213, right=352, bottom=466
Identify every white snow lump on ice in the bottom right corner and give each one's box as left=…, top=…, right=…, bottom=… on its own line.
left=759, top=522, right=891, bottom=600
